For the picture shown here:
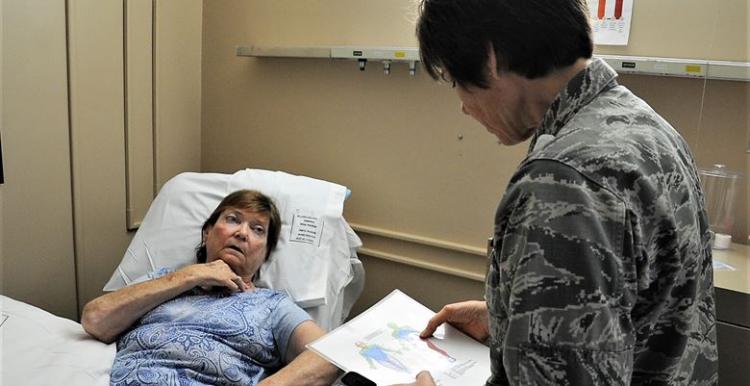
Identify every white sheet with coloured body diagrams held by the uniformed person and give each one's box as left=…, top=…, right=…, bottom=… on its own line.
left=308, top=290, right=490, bottom=386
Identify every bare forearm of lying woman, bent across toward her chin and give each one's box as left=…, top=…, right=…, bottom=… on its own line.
left=81, top=270, right=195, bottom=343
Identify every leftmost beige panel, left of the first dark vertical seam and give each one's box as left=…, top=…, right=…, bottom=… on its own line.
left=0, top=0, right=77, bottom=318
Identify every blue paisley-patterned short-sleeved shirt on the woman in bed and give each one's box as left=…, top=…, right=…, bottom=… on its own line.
left=110, top=269, right=310, bottom=385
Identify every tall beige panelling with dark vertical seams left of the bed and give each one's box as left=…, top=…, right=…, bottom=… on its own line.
left=0, top=0, right=202, bottom=320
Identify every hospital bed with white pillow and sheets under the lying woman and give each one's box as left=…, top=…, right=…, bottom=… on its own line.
left=0, top=169, right=364, bottom=385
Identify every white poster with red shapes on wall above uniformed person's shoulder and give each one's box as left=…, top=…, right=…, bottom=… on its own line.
left=588, top=0, right=633, bottom=46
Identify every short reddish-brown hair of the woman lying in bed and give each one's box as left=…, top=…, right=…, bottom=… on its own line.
left=195, top=190, right=281, bottom=263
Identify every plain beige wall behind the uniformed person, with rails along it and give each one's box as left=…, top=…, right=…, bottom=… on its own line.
left=202, top=0, right=750, bottom=309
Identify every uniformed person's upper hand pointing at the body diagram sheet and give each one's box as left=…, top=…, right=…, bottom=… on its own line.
left=419, top=300, right=490, bottom=342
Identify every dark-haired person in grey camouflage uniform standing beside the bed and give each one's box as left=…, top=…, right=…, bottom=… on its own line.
left=400, top=0, right=718, bottom=385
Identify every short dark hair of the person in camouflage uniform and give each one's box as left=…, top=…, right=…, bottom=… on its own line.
left=416, top=0, right=594, bottom=88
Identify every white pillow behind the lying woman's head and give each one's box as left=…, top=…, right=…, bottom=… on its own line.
left=104, top=169, right=359, bottom=307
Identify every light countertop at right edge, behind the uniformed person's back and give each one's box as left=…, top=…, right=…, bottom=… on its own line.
left=713, top=244, right=750, bottom=295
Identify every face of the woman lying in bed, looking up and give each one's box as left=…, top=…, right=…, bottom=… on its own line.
left=203, top=208, right=269, bottom=279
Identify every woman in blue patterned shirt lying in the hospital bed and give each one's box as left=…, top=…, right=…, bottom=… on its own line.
left=82, top=190, right=337, bottom=385
